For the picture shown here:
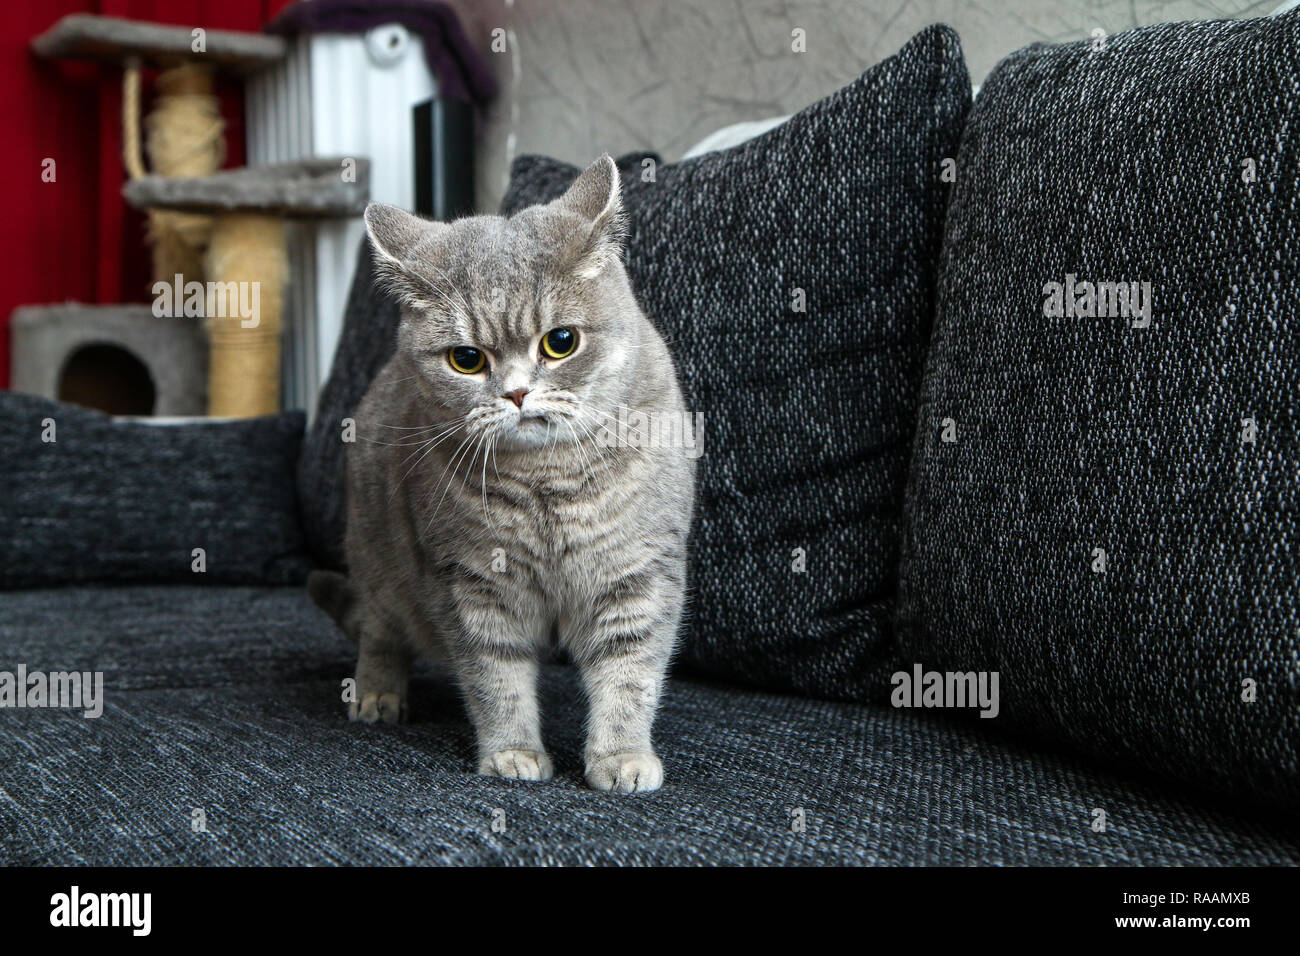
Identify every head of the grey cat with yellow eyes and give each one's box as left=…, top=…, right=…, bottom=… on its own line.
left=365, top=156, right=646, bottom=450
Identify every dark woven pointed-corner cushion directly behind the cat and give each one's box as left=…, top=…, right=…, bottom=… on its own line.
left=503, top=26, right=970, bottom=700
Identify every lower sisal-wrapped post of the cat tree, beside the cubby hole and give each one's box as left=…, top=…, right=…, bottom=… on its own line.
left=204, top=213, right=289, bottom=418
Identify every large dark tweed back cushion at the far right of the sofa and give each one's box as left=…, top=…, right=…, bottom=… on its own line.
left=900, top=13, right=1300, bottom=806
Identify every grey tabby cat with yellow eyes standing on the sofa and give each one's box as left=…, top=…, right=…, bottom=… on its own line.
left=313, top=156, right=694, bottom=793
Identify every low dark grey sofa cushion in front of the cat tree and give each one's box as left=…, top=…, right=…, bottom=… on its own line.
left=0, top=393, right=309, bottom=588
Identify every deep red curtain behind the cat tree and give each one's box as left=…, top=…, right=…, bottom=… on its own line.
left=0, top=0, right=289, bottom=388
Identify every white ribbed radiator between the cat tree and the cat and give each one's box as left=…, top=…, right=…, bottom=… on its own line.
left=244, top=23, right=437, bottom=412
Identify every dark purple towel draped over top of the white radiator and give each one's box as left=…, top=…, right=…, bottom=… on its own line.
left=263, top=0, right=497, bottom=107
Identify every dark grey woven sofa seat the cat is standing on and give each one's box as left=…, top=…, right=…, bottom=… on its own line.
left=0, top=587, right=1300, bottom=865
